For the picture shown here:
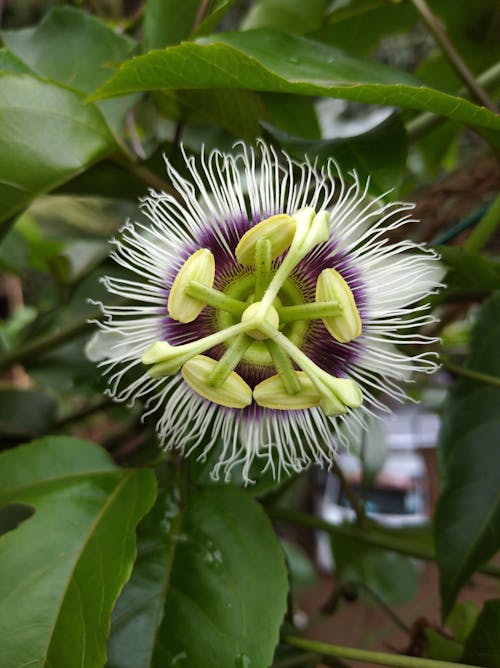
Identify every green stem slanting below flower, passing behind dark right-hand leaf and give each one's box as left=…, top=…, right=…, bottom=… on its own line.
left=268, top=508, right=500, bottom=579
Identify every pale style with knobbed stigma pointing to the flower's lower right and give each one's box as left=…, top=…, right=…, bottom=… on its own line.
left=261, top=324, right=363, bottom=416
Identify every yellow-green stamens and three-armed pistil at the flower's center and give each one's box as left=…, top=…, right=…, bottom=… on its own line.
left=142, top=208, right=362, bottom=415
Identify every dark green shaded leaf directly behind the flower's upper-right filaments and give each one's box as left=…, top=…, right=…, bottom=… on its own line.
left=263, top=114, right=408, bottom=195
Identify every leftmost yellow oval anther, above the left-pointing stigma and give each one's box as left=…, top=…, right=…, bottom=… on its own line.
left=167, top=248, right=215, bottom=322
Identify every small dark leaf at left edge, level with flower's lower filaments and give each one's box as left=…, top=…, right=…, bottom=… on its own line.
left=0, top=390, right=57, bottom=441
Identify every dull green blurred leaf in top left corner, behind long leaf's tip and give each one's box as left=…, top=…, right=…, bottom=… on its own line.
left=2, top=7, right=135, bottom=130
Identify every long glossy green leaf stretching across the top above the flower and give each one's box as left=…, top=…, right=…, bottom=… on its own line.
left=93, top=30, right=500, bottom=131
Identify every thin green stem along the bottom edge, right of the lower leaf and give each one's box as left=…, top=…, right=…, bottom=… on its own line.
left=283, top=636, right=479, bottom=668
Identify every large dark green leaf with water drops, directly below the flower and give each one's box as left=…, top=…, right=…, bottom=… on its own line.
left=109, top=486, right=287, bottom=668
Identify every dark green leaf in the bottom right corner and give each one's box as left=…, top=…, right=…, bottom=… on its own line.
left=462, top=599, right=500, bottom=668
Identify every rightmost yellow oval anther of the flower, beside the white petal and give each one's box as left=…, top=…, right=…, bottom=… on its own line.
left=316, top=269, right=362, bottom=343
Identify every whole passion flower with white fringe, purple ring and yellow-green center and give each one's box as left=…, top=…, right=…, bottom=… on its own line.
left=88, top=142, right=442, bottom=481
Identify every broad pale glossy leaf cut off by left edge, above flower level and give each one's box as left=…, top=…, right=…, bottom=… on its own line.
left=0, top=73, right=116, bottom=230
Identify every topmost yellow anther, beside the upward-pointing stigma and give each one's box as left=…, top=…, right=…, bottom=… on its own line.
left=235, top=213, right=295, bottom=266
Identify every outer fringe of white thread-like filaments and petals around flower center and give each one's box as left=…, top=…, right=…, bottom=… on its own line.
left=88, top=142, right=443, bottom=480
